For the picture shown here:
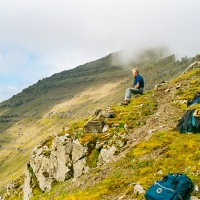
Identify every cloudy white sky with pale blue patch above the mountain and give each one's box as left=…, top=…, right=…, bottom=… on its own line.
left=0, top=0, right=200, bottom=102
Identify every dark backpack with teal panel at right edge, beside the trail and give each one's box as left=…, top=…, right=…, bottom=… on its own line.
left=177, top=110, right=200, bottom=133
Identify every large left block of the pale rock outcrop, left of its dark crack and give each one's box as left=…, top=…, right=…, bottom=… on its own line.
left=27, top=136, right=73, bottom=191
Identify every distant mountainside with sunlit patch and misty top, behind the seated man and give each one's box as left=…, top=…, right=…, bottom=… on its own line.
left=0, top=49, right=196, bottom=196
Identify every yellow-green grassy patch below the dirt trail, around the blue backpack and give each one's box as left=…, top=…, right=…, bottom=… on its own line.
left=33, top=131, right=200, bottom=200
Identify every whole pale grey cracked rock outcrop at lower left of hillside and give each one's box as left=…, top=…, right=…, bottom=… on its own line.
left=24, top=135, right=94, bottom=200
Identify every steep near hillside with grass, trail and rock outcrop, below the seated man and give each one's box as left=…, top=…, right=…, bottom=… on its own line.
left=3, top=65, right=200, bottom=200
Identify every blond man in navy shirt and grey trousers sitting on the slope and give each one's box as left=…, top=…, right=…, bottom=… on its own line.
left=122, top=68, right=144, bottom=105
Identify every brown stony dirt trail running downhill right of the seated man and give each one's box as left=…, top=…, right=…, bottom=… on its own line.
left=116, top=84, right=180, bottom=159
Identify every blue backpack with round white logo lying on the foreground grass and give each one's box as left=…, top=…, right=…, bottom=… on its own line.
left=144, top=174, right=194, bottom=200
